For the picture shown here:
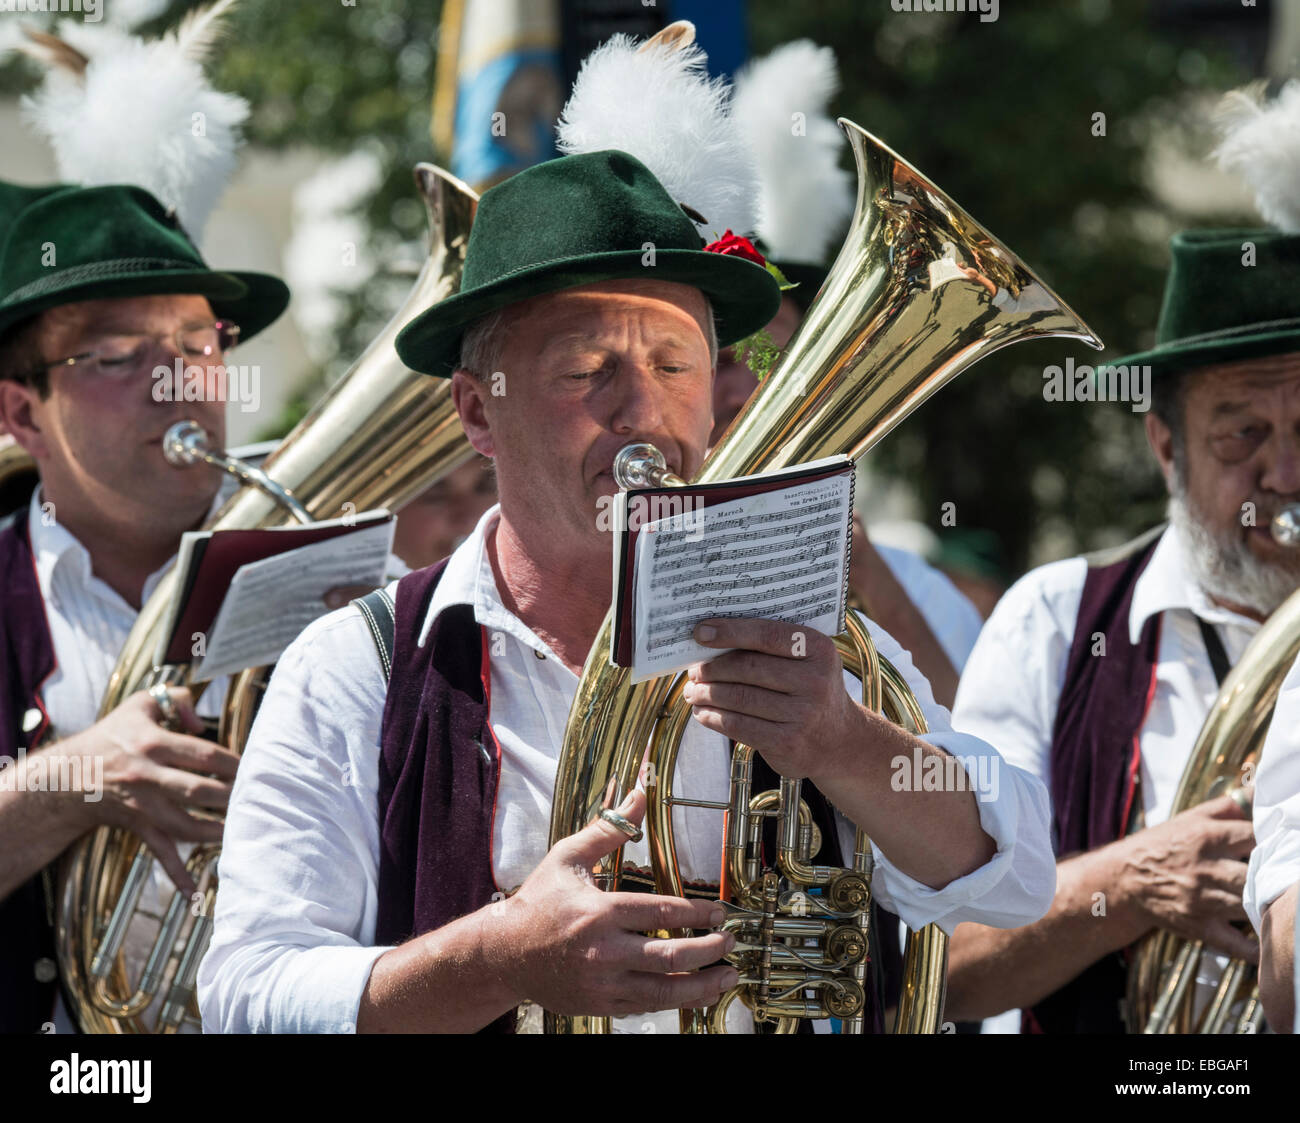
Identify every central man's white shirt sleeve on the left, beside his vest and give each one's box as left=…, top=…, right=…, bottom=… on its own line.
left=199, top=607, right=389, bottom=1033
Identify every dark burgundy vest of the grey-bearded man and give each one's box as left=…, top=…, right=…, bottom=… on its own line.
left=1023, top=526, right=1164, bottom=1033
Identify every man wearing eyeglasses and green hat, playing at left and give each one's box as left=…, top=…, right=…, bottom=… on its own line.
left=0, top=183, right=289, bottom=1032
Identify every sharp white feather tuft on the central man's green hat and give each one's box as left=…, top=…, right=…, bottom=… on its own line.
left=555, top=35, right=758, bottom=240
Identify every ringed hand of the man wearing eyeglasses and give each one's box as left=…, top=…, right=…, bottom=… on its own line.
left=55, top=686, right=239, bottom=893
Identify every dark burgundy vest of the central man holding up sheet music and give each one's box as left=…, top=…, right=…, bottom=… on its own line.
left=376, top=562, right=897, bottom=1033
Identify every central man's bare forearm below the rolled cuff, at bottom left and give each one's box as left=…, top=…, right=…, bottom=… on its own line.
left=356, top=906, right=521, bottom=1033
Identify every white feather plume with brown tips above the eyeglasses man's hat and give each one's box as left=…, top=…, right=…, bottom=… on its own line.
left=22, top=0, right=248, bottom=242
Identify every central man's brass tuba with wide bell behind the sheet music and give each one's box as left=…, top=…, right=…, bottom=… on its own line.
left=546, top=120, right=1100, bottom=1033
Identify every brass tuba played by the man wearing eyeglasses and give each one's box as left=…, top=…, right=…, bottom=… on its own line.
left=56, top=164, right=478, bottom=1033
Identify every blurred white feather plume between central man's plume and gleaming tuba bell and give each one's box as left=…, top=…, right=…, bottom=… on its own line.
left=732, top=39, right=854, bottom=265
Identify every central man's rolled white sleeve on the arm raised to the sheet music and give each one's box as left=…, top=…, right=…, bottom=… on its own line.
left=840, top=613, right=1056, bottom=933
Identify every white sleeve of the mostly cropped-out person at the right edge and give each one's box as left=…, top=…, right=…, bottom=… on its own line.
left=1244, top=660, right=1300, bottom=932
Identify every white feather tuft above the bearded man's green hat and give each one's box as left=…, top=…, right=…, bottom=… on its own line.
left=1214, top=79, right=1300, bottom=234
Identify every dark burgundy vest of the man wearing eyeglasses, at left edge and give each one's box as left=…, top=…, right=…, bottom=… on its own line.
left=0, top=504, right=57, bottom=1033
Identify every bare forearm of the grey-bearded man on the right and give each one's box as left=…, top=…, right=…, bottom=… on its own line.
left=944, top=842, right=1149, bottom=1022
